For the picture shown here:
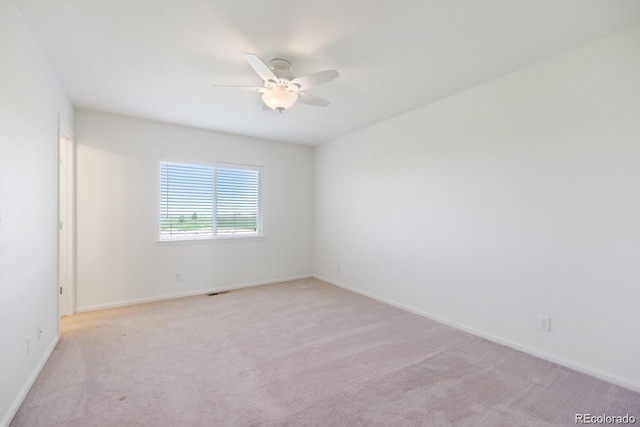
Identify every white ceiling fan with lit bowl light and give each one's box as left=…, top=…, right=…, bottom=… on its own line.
left=214, top=53, right=340, bottom=113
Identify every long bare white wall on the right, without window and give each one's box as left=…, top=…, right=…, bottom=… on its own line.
left=314, top=27, right=640, bottom=391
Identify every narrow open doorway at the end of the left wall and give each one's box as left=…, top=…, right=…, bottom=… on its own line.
left=58, top=127, right=75, bottom=317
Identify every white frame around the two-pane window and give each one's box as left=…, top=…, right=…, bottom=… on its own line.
left=156, top=157, right=264, bottom=243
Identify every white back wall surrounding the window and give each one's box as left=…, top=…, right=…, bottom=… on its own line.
left=75, top=111, right=312, bottom=311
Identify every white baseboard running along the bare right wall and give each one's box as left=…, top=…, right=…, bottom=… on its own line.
left=313, top=275, right=640, bottom=393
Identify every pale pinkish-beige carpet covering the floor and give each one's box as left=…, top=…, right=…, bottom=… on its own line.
left=11, top=279, right=640, bottom=427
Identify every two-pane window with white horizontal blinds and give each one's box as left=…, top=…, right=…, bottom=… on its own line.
left=160, top=161, right=262, bottom=240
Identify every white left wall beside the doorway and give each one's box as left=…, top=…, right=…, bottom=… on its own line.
left=0, top=0, right=73, bottom=426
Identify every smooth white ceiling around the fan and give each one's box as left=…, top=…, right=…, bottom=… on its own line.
left=14, top=0, right=640, bottom=145
